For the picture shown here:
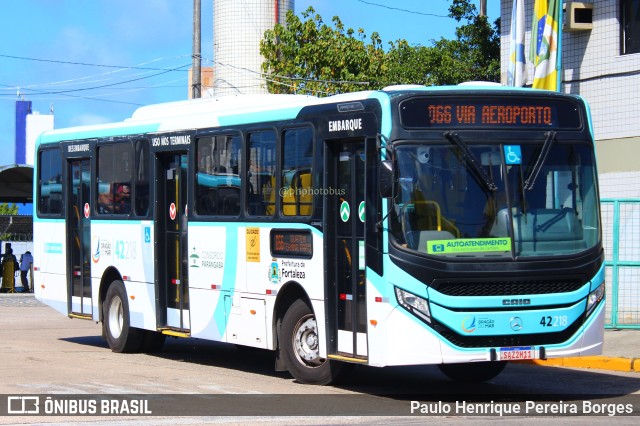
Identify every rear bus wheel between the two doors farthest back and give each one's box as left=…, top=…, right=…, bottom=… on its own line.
left=102, top=281, right=143, bottom=352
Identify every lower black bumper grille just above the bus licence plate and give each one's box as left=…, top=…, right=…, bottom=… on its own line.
left=432, top=315, right=584, bottom=348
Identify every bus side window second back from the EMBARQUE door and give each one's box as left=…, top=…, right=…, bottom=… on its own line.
left=247, top=130, right=276, bottom=216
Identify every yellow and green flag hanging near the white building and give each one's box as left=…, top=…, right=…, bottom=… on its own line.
left=533, top=0, right=562, bottom=90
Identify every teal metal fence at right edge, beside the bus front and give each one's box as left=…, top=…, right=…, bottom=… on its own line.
left=601, top=198, right=640, bottom=329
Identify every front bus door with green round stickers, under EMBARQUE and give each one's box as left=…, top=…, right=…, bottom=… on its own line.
left=325, top=140, right=367, bottom=359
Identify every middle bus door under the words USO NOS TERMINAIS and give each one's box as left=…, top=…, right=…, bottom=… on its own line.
left=155, top=153, right=190, bottom=331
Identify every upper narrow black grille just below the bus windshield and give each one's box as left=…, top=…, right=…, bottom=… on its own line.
left=431, top=279, right=586, bottom=296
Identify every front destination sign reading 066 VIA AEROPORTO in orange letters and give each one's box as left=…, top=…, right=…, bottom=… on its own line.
left=400, top=97, right=580, bottom=129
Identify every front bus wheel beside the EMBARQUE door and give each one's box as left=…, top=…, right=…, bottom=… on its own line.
left=279, top=299, right=342, bottom=385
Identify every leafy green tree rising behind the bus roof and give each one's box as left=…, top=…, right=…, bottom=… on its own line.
left=260, top=0, right=500, bottom=96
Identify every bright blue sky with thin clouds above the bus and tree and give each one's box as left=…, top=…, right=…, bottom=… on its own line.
left=0, top=0, right=500, bottom=161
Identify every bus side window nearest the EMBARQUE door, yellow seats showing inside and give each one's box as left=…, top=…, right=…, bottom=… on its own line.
left=278, top=128, right=313, bottom=216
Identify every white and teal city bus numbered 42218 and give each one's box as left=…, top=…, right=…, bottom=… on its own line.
left=34, top=86, right=605, bottom=384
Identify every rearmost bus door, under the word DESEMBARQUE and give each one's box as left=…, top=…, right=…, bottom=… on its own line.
left=66, top=158, right=92, bottom=317
